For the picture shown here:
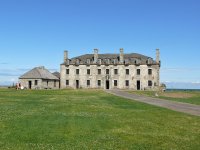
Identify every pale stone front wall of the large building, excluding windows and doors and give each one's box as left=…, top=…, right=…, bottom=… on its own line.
left=60, top=64, right=160, bottom=90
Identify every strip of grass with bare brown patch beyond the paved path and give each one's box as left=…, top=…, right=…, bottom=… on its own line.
left=128, top=91, right=200, bottom=105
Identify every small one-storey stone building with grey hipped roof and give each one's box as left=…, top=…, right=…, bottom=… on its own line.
left=19, top=66, right=59, bottom=89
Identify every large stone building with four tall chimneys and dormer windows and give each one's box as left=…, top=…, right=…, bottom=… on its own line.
left=60, top=49, right=160, bottom=90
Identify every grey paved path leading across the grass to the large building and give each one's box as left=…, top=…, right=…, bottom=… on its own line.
left=106, top=90, right=200, bottom=116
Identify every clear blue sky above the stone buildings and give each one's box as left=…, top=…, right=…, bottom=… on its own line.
left=0, top=0, right=200, bottom=88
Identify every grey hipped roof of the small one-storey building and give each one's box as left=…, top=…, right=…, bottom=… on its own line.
left=19, top=66, right=59, bottom=80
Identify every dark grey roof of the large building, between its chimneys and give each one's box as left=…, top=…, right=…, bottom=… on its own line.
left=61, top=53, right=157, bottom=65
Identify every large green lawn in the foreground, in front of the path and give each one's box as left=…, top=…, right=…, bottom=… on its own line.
left=0, top=89, right=200, bottom=150
